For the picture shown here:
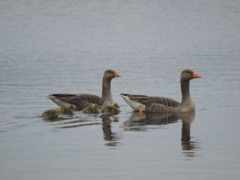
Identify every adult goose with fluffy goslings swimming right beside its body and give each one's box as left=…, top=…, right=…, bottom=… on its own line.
left=48, top=69, right=122, bottom=111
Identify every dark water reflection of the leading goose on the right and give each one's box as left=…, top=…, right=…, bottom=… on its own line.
left=123, top=111, right=199, bottom=157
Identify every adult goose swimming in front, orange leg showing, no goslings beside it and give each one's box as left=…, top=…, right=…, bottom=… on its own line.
left=120, top=69, right=201, bottom=113
